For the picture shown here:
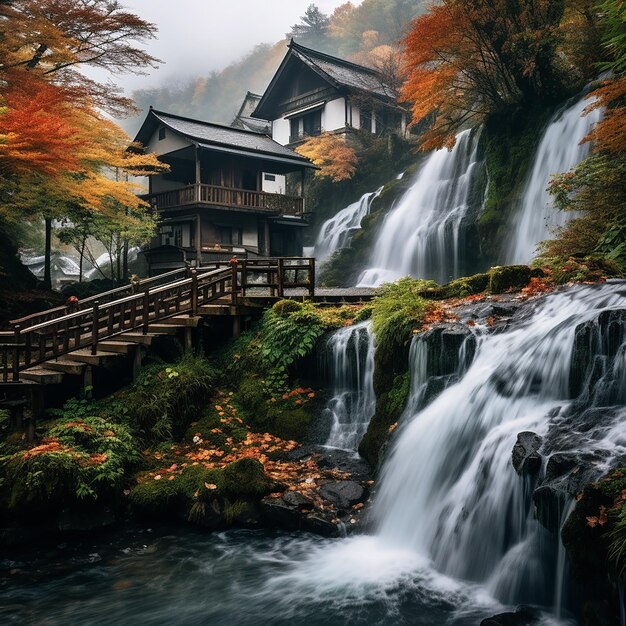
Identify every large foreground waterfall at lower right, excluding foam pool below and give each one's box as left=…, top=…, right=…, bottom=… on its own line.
left=373, top=283, right=626, bottom=606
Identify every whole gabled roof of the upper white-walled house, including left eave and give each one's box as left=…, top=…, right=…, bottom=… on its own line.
left=252, top=39, right=396, bottom=119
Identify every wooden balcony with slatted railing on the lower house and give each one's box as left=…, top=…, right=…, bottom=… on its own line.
left=142, top=184, right=304, bottom=215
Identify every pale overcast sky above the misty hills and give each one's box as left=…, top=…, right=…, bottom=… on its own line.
left=111, top=0, right=360, bottom=90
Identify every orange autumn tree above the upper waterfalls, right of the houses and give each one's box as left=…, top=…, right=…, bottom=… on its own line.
left=402, top=0, right=563, bottom=148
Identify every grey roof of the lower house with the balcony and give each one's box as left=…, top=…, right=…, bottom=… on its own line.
left=135, top=108, right=315, bottom=167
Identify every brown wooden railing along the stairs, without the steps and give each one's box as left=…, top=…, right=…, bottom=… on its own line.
left=0, top=257, right=315, bottom=383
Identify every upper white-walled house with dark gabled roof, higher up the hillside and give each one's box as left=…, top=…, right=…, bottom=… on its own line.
left=251, top=41, right=406, bottom=146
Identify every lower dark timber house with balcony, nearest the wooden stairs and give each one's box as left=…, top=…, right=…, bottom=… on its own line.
left=135, top=109, right=314, bottom=273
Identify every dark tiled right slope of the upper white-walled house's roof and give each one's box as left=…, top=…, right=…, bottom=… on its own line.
left=289, top=41, right=395, bottom=98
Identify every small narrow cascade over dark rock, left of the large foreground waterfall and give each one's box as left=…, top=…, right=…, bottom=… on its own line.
left=325, top=321, right=376, bottom=451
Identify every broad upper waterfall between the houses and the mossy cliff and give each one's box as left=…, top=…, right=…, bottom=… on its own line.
left=359, top=130, right=480, bottom=287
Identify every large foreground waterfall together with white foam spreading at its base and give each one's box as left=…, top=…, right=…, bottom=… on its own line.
left=265, top=283, right=626, bottom=623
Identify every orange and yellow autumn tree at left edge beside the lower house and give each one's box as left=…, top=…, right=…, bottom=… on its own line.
left=0, top=0, right=165, bottom=286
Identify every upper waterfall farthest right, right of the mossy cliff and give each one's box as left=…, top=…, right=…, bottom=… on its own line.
left=505, top=98, right=602, bottom=263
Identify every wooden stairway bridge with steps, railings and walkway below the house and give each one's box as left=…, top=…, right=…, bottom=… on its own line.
left=0, top=257, right=374, bottom=432
